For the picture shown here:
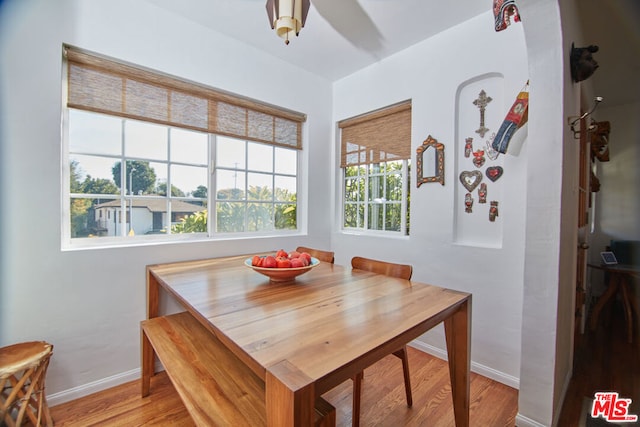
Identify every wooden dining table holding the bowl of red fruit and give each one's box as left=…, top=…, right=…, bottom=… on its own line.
left=148, top=255, right=471, bottom=427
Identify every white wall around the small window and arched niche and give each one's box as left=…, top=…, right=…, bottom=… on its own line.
left=333, top=12, right=528, bottom=387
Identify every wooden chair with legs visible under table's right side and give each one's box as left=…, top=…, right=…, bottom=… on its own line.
left=351, top=257, right=413, bottom=426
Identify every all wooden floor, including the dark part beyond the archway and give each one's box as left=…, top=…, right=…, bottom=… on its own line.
left=51, top=304, right=640, bottom=427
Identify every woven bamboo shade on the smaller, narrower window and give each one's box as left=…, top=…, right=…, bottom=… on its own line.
left=338, top=101, right=411, bottom=168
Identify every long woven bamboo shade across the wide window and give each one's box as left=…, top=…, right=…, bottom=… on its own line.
left=64, top=46, right=306, bottom=149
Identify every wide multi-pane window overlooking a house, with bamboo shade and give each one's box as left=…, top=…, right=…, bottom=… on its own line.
left=62, top=47, right=304, bottom=247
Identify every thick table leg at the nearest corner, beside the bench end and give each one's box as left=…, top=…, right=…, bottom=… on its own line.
left=265, top=361, right=315, bottom=427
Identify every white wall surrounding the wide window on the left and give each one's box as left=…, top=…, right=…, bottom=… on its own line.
left=0, top=0, right=332, bottom=404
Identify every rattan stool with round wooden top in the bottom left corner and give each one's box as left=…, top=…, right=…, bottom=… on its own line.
left=0, top=341, right=53, bottom=427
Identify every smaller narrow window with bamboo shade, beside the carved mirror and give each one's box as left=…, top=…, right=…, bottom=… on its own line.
left=339, top=102, right=411, bottom=235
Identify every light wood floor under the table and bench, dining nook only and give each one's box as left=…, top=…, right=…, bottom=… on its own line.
left=51, top=348, right=518, bottom=427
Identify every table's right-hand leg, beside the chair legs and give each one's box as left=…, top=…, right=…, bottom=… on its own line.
left=444, top=297, right=471, bottom=427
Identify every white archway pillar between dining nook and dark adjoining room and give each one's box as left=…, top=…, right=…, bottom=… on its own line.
left=516, top=0, right=580, bottom=427
